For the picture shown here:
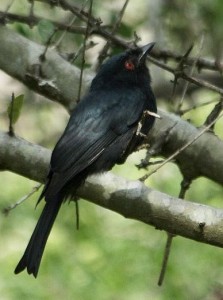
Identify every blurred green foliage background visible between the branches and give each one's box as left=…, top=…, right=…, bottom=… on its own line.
left=0, top=0, right=223, bottom=300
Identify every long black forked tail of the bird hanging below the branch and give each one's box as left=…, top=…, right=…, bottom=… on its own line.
left=15, top=195, right=63, bottom=277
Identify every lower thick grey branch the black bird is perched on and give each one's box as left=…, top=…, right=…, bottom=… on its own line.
left=0, top=132, right=223, bottom=247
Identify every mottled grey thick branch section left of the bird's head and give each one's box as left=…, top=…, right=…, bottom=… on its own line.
left=0, top=25, right=92, bottom=109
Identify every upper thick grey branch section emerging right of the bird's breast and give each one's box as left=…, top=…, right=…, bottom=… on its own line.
left=151, top=111, right=223, bottom=184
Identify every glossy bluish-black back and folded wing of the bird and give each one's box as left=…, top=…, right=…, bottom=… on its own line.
left=47, top=89, right=147, bottom=190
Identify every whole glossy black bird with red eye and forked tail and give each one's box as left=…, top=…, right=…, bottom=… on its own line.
left=15, top=43, right=157, bottom=277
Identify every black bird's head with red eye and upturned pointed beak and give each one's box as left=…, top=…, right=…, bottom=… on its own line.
left=91, top=43, right=155, bottom=89
